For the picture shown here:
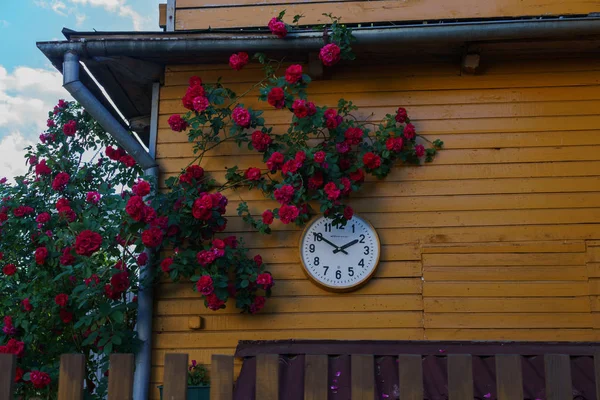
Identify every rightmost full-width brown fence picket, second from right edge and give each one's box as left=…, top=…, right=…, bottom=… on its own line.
left=544, top=354, right=573, bottom=400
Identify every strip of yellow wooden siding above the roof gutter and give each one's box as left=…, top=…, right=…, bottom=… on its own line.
left=175, top=0, right=600, bottom=30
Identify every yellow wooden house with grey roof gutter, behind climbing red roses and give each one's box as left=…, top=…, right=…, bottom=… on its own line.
left=38, top=0, right=600, bottom=398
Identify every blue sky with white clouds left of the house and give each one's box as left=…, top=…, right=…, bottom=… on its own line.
left=0, top=0, right=161, bottom=177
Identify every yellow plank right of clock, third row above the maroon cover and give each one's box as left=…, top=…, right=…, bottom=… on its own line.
left=423, top=296, right=600, bottom=314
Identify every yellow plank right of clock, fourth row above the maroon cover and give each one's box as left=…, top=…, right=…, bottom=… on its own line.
left=423, top=281, right=594, bottom=297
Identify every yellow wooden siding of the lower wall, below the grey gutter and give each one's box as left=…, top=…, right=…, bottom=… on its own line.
left=153, top=59, right=600, bottom=396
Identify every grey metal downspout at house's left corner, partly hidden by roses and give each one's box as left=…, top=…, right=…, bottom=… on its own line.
left=63, top=52, right=158, bottom=400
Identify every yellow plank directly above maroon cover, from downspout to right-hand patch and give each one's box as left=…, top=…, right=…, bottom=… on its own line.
left=152, top=328, right=423, bottom=349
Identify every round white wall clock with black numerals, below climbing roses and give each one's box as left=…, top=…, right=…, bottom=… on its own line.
left=300, top=215, right=381, bottom=292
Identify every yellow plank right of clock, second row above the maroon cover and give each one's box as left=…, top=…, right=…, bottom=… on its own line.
left=425, top=313, right=592, bottom=329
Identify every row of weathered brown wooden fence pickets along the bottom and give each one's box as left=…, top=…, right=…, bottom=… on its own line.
left=0, top=354, right=600, bottom=400
